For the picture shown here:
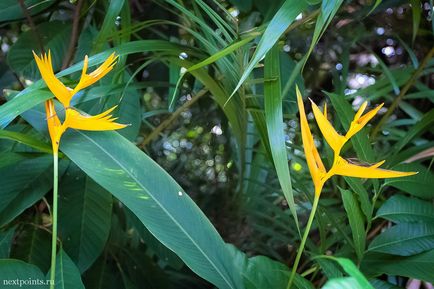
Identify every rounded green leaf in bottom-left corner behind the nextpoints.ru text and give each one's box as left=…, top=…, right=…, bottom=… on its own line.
left=0, top=259, right=48, bottom=289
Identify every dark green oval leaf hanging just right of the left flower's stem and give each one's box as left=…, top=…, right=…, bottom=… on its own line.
left=59, top=165, right=112, bottom=272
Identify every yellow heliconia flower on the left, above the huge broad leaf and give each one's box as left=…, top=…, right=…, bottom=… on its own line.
left=33, top=52, right=126, bottom=153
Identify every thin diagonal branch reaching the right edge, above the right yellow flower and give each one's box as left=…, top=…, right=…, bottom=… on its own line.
left=371, top=47, right=434, bottom=139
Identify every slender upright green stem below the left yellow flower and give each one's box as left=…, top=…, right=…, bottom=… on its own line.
left=50, top=152, right=59, bottom=289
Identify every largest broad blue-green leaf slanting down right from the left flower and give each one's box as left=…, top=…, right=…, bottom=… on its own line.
left=62, top=130, right=242, bottom=288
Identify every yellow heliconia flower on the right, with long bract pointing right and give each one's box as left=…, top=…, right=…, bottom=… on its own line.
left=296, top=87, right=416, bottom=196
